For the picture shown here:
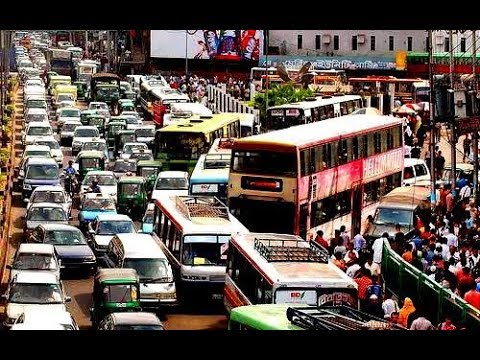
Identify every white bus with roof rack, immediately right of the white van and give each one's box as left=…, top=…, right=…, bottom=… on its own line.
left=153, top=194, right=248, bottom=301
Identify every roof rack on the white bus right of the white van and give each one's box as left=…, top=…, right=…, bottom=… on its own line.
left=175, top=195, right=230, bottom=220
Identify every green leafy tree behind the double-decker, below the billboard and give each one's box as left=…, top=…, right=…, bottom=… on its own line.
left=254, top=82, right=314, bottom=124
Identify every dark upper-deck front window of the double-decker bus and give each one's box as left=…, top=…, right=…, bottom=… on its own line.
left=232, top=151, right=297, bottom=177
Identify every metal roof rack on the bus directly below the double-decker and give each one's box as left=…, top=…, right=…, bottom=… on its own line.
left=253, top=238, right=330, bottom=264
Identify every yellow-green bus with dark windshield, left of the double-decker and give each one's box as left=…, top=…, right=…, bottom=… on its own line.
left=154, top=113, right=241, bottom=174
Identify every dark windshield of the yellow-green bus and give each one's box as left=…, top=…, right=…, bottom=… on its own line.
left=159, top=132, right=209, bottom=160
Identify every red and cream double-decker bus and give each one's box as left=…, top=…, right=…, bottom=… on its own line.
left=228, top=115, right=404, bottom=238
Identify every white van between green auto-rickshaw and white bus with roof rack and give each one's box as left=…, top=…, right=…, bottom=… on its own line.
left=104, top=234, right=177, bottom=308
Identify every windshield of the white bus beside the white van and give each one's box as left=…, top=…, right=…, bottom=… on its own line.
left=183, top=234, right=230, bottom=265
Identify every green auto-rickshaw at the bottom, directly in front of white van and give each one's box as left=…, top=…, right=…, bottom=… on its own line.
left=90, top=268, right=141, bottom=328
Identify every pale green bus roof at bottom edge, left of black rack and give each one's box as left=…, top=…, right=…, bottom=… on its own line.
left=228, top=304, right=304, bottom=330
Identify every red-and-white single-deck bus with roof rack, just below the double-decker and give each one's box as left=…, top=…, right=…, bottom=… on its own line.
left=223, top=233, right=358, bottom=312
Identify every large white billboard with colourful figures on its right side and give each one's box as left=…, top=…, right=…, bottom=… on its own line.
left=150, top=30, right=263, bottom=61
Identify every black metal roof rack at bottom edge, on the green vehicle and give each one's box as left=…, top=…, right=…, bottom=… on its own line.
left=287, top=305, right=406, bottom=330
